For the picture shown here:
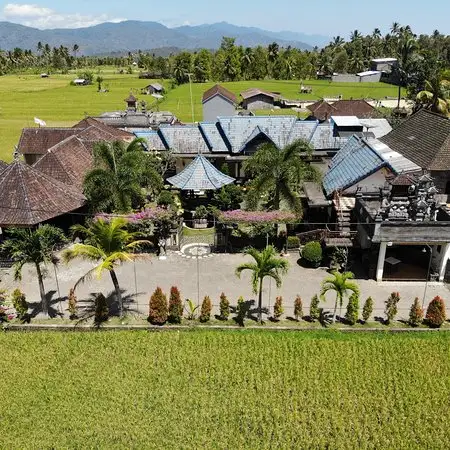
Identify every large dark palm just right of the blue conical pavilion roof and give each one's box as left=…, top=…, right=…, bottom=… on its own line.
left=244, top=140, right=320, bottom=212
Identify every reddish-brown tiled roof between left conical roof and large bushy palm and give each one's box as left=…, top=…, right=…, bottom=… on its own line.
left=33, top=136, right=93, bottom=192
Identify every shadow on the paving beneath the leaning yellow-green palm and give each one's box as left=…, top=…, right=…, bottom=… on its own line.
left=76, top=289, right=142, bottom=326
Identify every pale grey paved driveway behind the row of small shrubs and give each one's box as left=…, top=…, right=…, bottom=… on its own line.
left=2, top=253, right=450, bottom=318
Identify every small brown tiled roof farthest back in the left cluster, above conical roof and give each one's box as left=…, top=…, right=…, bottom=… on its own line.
left=18, top=128, right=82, bottom=155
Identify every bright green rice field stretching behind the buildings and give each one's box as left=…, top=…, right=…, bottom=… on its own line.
left=0, top=68, right=397, bottom=161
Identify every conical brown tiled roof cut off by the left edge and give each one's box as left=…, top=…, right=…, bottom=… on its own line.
left=0, top=160, right=86, bottom=226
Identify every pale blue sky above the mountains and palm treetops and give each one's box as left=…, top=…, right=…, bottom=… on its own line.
left=0, top=0, right=450, bottom=37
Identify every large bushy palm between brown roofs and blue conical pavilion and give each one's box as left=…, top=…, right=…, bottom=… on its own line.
left=83, top=139, right=162, bottom=213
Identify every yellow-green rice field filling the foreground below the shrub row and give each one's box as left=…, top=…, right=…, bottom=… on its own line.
left=0, top=331, right=450, bottom=449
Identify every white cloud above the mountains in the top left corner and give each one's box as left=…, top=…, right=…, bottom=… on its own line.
left=3, top=3, right=126, bottom=29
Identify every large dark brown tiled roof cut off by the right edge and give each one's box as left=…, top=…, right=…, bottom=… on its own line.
left=380, top=109, right=450, bottom=170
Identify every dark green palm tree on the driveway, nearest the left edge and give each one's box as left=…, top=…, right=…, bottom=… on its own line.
left=1, top=225, right=66, bottom=316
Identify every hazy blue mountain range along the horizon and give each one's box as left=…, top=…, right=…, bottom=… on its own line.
left=0, top=20, right=330, bottom=55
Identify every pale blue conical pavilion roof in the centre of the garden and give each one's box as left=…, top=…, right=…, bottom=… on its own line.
left=167, top=155, right=235, bottom=191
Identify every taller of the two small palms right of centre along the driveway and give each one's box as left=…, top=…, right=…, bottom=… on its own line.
left=236, top=245, right=289, bottom=323
